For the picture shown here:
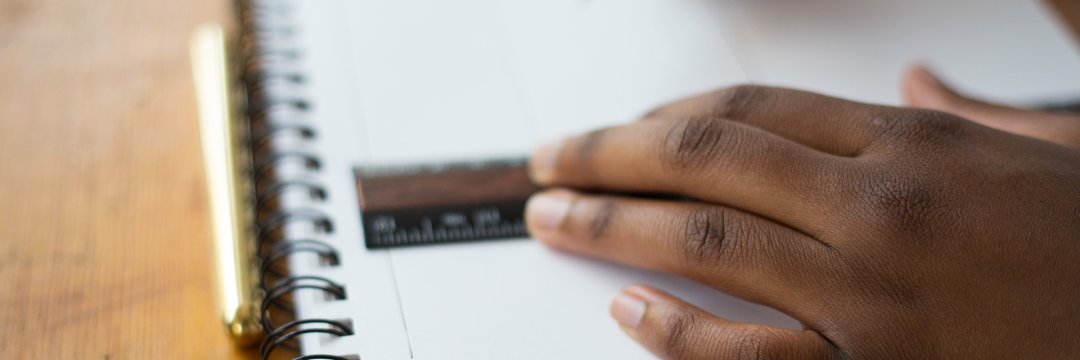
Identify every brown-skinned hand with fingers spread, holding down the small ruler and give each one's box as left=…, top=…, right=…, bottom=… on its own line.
left=526, top=68, right=1080, bottom=359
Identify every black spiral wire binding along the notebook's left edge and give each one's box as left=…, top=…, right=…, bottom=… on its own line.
left=237, top=0, right=357, bottom=360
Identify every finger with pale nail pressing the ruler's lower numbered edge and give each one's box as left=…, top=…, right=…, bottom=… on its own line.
left=526, top=189, right=832, bottom=309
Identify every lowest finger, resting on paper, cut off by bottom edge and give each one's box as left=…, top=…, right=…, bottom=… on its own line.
left=611, top=285, right=837, bottom=359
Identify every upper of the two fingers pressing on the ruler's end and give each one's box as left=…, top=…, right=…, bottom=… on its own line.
left=530, top=118, right=853, bottom=231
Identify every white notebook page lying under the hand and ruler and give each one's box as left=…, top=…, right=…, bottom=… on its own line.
left=280, top=0, right=1080, bottom=359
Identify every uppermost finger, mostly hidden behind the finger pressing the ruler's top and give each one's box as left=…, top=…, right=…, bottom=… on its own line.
left=646, top=85, right=888, bottom=157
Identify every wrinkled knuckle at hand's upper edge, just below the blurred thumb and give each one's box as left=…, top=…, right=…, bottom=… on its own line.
left=877, top=109, right=968, bottom=148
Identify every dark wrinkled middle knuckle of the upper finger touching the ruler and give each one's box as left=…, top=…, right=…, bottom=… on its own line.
left=660, top=118, right=734, bottom=172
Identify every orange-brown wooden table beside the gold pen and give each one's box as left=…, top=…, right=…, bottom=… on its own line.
left=0, top=0, right=1080, bottom=359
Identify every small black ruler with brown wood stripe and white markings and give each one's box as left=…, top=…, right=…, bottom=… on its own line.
left=355, top=159, right=536, bottom=249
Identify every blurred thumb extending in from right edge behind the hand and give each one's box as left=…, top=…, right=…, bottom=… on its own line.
left=904, top=66, right=1080, bottom=147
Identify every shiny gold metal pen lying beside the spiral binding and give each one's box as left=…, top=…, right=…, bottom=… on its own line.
left=191, top=24, right=264, bottom=345
